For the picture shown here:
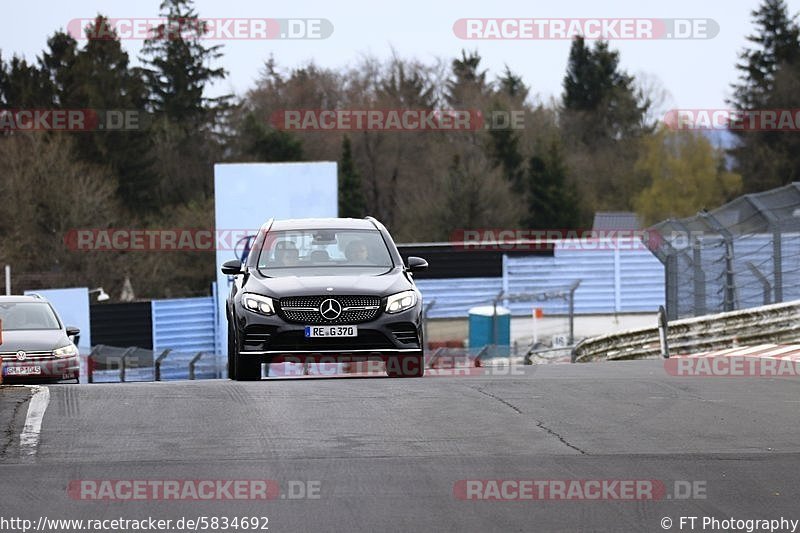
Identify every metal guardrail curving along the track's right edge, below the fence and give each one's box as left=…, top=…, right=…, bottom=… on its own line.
left=572, top=300, right=800, bottom=363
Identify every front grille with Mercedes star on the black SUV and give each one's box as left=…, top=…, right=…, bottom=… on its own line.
left=278, top=296, right=381, bottom=324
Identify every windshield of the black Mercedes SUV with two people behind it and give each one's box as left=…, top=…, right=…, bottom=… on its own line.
left=258, top=229, right=394, bottom=277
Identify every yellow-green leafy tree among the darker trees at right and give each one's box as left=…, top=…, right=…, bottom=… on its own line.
left=633, top=127, right=742, bottom=224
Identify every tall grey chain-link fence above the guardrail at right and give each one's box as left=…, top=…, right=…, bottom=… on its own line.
left=648, top=182, right=800, bottom=320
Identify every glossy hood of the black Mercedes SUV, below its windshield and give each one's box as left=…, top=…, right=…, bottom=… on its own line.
left=244, top=269, right=413, bottom=298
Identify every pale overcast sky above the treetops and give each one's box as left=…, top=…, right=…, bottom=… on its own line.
left=0, top=0, right=800, bottom=115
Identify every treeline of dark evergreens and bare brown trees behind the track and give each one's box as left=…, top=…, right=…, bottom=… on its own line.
left=0, top=0, right=800, bottom=297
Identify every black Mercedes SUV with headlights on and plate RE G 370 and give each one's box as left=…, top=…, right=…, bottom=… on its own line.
left=222, top=217, right=428, bottom=380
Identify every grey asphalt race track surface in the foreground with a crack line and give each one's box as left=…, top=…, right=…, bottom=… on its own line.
left=0, top=360, right=800, bottom=531
